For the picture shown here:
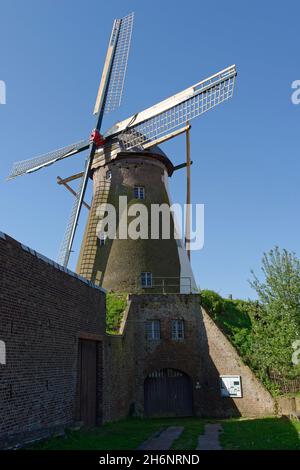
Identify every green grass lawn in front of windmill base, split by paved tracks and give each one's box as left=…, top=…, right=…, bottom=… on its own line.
left=30, top=418, right=300, bottom=450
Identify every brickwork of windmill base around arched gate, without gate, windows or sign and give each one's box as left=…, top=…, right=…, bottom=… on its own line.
left=104, top=294, right=274, bottom=420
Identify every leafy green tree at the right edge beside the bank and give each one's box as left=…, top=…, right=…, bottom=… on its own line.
left=250, top=247, right=300, bottom=378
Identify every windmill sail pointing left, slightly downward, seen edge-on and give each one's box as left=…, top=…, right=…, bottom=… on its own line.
left=8, top=140, right=89, bottom=179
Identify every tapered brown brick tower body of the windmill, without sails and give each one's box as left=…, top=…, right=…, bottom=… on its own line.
left=77, top=153, right=180, bottom=293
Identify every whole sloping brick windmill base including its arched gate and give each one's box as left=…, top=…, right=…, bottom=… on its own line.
left=103, top=294, right=274, bottom=421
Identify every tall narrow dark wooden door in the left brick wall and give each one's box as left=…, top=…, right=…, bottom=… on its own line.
left=79, top=339, right=97, bottom=427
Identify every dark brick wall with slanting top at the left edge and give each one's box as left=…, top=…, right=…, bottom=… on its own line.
left=0, top=233, right=105, bottom=447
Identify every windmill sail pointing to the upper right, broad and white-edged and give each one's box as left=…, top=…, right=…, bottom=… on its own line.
left=105, top=65, right=237, bottom=150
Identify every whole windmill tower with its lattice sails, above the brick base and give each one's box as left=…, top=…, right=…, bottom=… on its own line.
left=9, top=14, right=236, bottom=293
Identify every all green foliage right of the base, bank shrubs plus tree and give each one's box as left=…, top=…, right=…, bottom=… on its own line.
left=201, top=247, right=300, bottom=394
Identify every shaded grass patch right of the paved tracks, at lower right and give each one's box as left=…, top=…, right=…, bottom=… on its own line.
left=220, top=417, right=300, bottom=450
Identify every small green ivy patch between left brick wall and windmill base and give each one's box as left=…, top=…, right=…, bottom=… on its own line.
left=106, top=292, right=127, bottom=334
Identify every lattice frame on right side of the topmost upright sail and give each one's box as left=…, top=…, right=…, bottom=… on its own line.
left=105, top=13, right=134, bottom=113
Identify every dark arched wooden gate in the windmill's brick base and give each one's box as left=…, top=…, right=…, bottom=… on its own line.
left=144, top=369, right=193, bottom=416
